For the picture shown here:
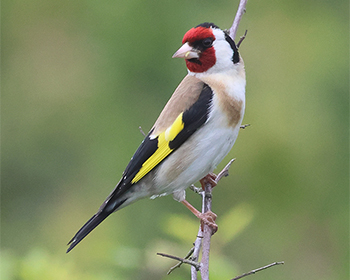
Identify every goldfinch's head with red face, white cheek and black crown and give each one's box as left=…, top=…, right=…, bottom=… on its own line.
left=173, top=22, right=240, bottom=73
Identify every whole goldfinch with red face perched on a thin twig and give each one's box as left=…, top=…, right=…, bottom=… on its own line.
left=67, top=22, right=246, bottom=253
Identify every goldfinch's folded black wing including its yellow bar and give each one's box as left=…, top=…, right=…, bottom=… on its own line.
left=114, top=77, right=213, bottom=196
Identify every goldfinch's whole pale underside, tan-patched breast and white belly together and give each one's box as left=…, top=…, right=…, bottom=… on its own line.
left=150, top=61, right=245, bottom=200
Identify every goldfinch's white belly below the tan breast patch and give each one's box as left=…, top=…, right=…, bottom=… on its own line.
left=152, top=104, right=243, bottom=200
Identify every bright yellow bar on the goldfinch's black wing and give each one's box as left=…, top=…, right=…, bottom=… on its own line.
left=131, top=113, right=184, bottom=184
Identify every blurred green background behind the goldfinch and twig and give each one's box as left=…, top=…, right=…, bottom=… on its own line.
left=1, top=0, right=349, bottom=280
